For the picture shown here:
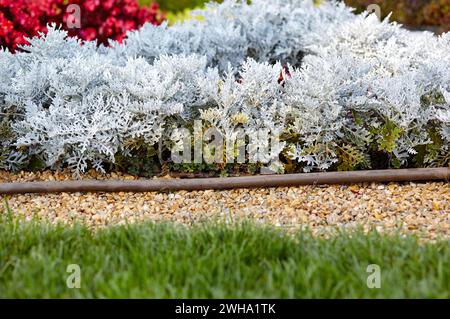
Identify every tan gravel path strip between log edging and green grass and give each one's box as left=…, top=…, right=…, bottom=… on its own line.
left=0, top=172, right=450, bottom=239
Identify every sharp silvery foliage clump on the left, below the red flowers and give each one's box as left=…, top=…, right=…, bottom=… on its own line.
left=5, top=29, right=217, bottom=173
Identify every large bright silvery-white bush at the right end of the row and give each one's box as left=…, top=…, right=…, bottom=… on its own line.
left=286, top=14, right=450, bottom=170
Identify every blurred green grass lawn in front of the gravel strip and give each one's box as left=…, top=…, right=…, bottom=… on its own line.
left=0, top=213, right=450, bottom=298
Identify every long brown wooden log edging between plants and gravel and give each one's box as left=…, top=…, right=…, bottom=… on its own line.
left=0, top=167, right=450, bottom=194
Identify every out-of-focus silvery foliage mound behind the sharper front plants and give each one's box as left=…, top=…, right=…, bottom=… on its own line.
left=112, top=0, right=354, bottom=71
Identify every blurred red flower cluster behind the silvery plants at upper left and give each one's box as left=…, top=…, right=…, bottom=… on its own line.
left=0, top=0, right=164, bottom=52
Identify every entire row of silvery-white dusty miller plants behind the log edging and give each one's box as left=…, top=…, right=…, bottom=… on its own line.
left=0, top=0, right=450, bottom=173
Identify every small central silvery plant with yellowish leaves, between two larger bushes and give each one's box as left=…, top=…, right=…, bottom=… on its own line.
left=200, top=58, right=290, bottom=171
